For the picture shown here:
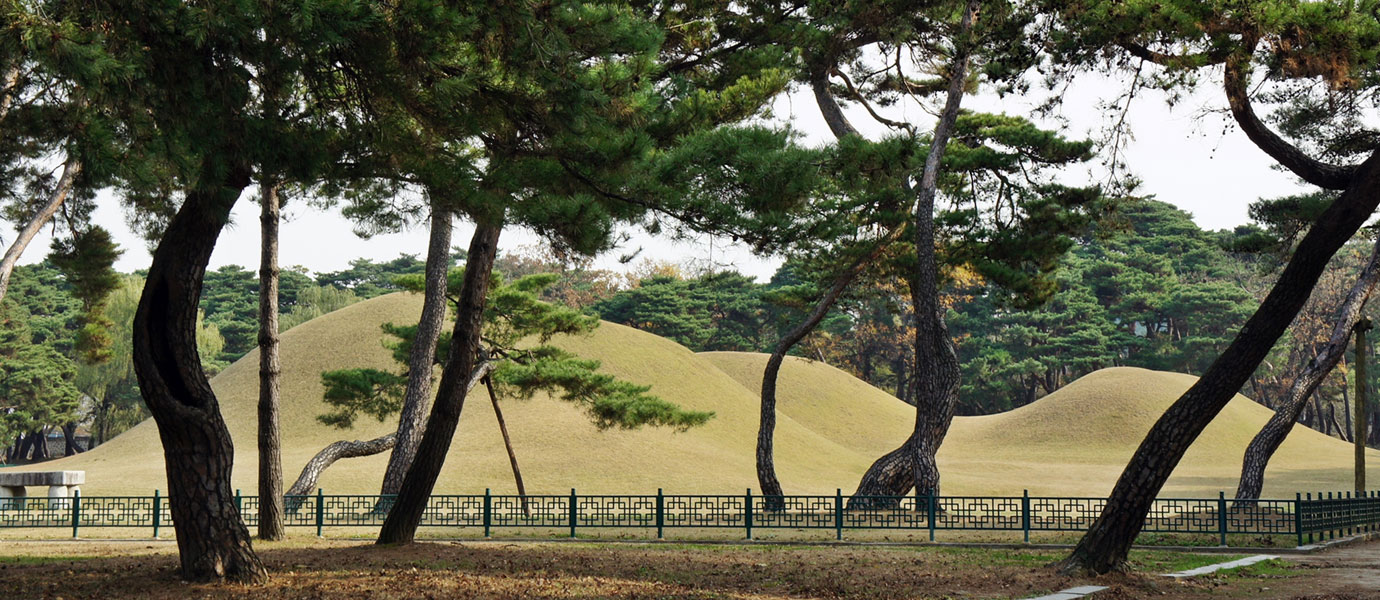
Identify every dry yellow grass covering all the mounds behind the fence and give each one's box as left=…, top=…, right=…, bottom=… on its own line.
left=21, top=294, right=1380, bottom=497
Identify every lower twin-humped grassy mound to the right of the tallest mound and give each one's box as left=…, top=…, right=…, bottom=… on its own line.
left=704, top=353, right=1380, bottom=498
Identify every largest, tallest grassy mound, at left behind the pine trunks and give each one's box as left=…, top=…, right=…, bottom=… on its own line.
left=44, top=294, right=869, bottom=495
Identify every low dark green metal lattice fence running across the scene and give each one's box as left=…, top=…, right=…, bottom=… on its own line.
left=0, top=490, right=1380, bottom=545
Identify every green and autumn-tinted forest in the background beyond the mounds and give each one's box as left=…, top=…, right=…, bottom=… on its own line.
left=10, top=200, right=1380, bottom=462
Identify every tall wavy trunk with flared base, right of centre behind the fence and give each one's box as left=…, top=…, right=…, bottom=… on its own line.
left=854, top=0, right=978, bottom=497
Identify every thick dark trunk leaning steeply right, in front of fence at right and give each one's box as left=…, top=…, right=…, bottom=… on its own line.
left=1060, top=148, right=1380, bottom=574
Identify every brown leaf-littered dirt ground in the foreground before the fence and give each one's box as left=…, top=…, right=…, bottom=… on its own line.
left=0, top=539, right=1380, bottom=600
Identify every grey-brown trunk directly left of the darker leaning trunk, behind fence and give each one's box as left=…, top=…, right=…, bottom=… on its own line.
left=380, top=201, right=451, bottom=495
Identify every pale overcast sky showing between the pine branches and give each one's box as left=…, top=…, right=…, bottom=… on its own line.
left=0, top=69, right=1303, bottom=280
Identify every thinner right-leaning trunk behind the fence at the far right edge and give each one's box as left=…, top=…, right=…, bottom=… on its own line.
left=1236, top=240, right=1380, bottom=501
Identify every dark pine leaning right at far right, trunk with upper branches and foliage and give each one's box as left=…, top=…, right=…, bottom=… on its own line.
left=1046, top=0, right=1380, bottom=572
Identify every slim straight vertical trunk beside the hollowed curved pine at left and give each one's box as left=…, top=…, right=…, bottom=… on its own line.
left=258, top=177, right=287, bottom=539
